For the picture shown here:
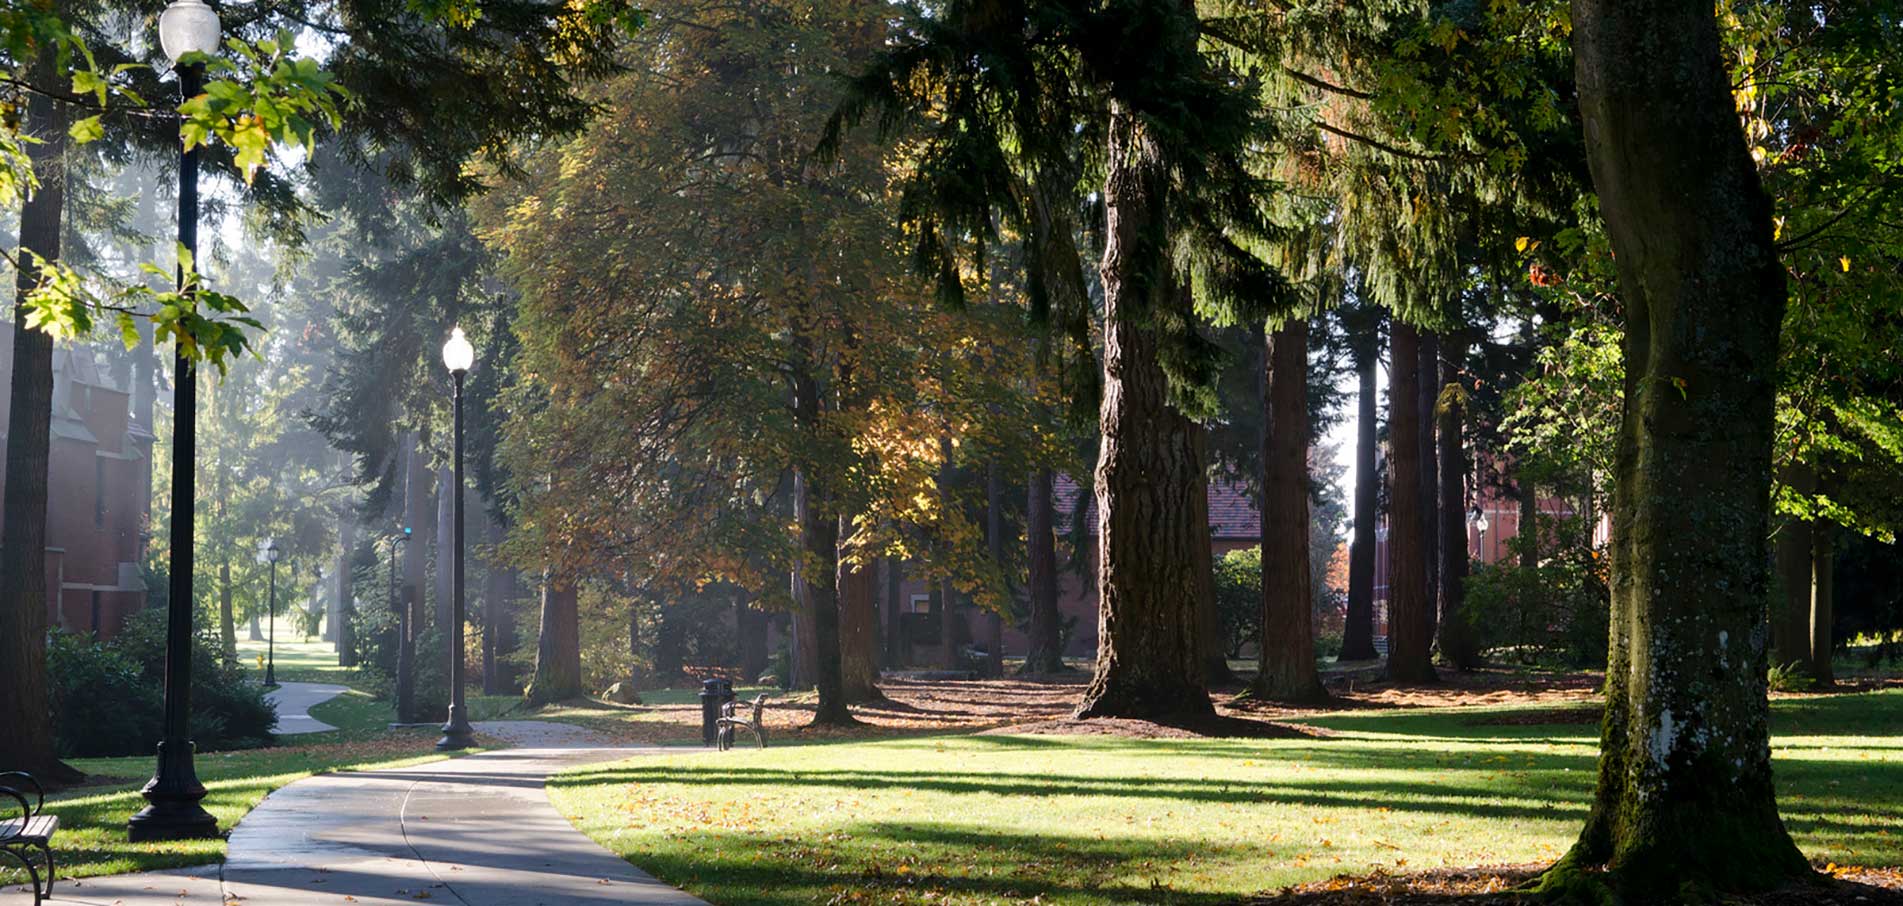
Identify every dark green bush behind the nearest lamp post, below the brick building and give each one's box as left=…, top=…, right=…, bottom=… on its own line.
left=48, top=609, right=278, bottom=758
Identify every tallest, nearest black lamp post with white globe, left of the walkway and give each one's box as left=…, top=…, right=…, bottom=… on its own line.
left=126, top=0, right=219, bottom=843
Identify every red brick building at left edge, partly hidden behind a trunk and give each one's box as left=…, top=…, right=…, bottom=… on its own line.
left=0, top=324, right=152, bottom=638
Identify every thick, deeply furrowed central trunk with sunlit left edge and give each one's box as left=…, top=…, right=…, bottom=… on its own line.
left=1077, top=98, right=1214, bottom=719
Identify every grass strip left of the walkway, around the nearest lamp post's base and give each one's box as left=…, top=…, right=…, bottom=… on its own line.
left=12, top=692, right=460, bottom=883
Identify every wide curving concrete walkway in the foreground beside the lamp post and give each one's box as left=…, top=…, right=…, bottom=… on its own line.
left=0, top=721, right=702, bottom=906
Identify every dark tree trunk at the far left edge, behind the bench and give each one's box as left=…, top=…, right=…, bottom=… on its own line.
left=0, top=65, right=67, bottom=780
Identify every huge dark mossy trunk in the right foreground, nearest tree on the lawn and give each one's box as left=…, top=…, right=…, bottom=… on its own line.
left=1545, top=0, right=1810, bottom=890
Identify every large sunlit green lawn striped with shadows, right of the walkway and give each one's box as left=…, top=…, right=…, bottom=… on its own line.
left=550, top=689, right=1903, bottom=906
